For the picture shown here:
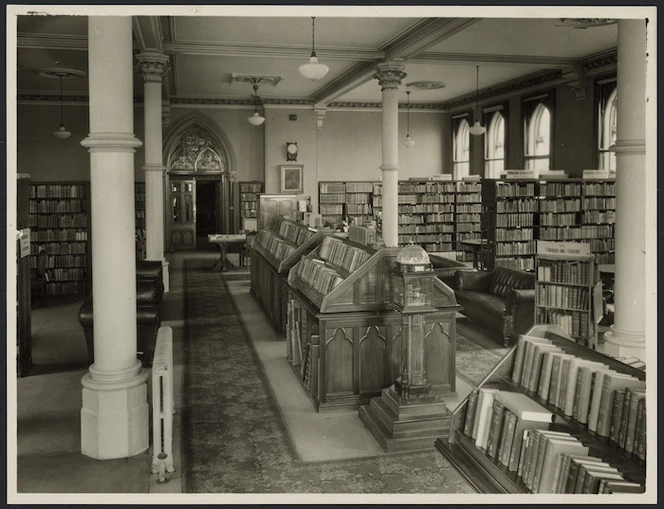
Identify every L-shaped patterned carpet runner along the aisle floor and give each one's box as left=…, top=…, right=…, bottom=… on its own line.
left=182, top=260, right=474, bottom=494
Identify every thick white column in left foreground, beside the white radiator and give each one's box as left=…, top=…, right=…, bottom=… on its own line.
left=81, top=16, right=149, bottom=459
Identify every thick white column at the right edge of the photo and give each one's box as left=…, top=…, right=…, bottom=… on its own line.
left=604, top=19, right=644, bottom=361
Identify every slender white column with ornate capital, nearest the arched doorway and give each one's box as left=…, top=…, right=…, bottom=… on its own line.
left=136, top=52, right=169, bottom=292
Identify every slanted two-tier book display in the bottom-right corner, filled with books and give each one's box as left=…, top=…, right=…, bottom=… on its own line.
left=435, top=325, right=647, bottom=494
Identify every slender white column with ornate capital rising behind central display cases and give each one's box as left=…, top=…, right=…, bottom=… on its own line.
left=374, top=60, right=406, bottom=247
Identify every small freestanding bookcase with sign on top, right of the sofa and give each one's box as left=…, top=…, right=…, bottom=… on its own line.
left=534, top=241, right=602, bottom=348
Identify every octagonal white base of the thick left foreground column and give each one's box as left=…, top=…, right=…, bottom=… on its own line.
left=81, top=361, right=150, bottom=460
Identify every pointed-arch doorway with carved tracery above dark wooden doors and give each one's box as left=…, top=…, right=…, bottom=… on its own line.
left=164, top=115, right=237, bottom=251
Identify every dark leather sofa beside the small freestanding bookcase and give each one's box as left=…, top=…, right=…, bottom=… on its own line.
left=454, top=267, right=535, bottom=346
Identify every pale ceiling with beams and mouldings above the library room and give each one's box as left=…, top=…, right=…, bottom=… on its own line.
left=16, top=14, right=618, bottom=106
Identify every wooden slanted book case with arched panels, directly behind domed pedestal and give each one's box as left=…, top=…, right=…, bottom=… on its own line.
left=286, top=234, right=459, bottom=411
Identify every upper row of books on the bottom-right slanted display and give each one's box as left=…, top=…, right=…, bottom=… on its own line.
left=512, top=335, right=645, bottom=446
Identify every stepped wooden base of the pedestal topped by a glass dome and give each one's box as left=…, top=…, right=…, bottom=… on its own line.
left=359, top=386, right=452, bottom=452
